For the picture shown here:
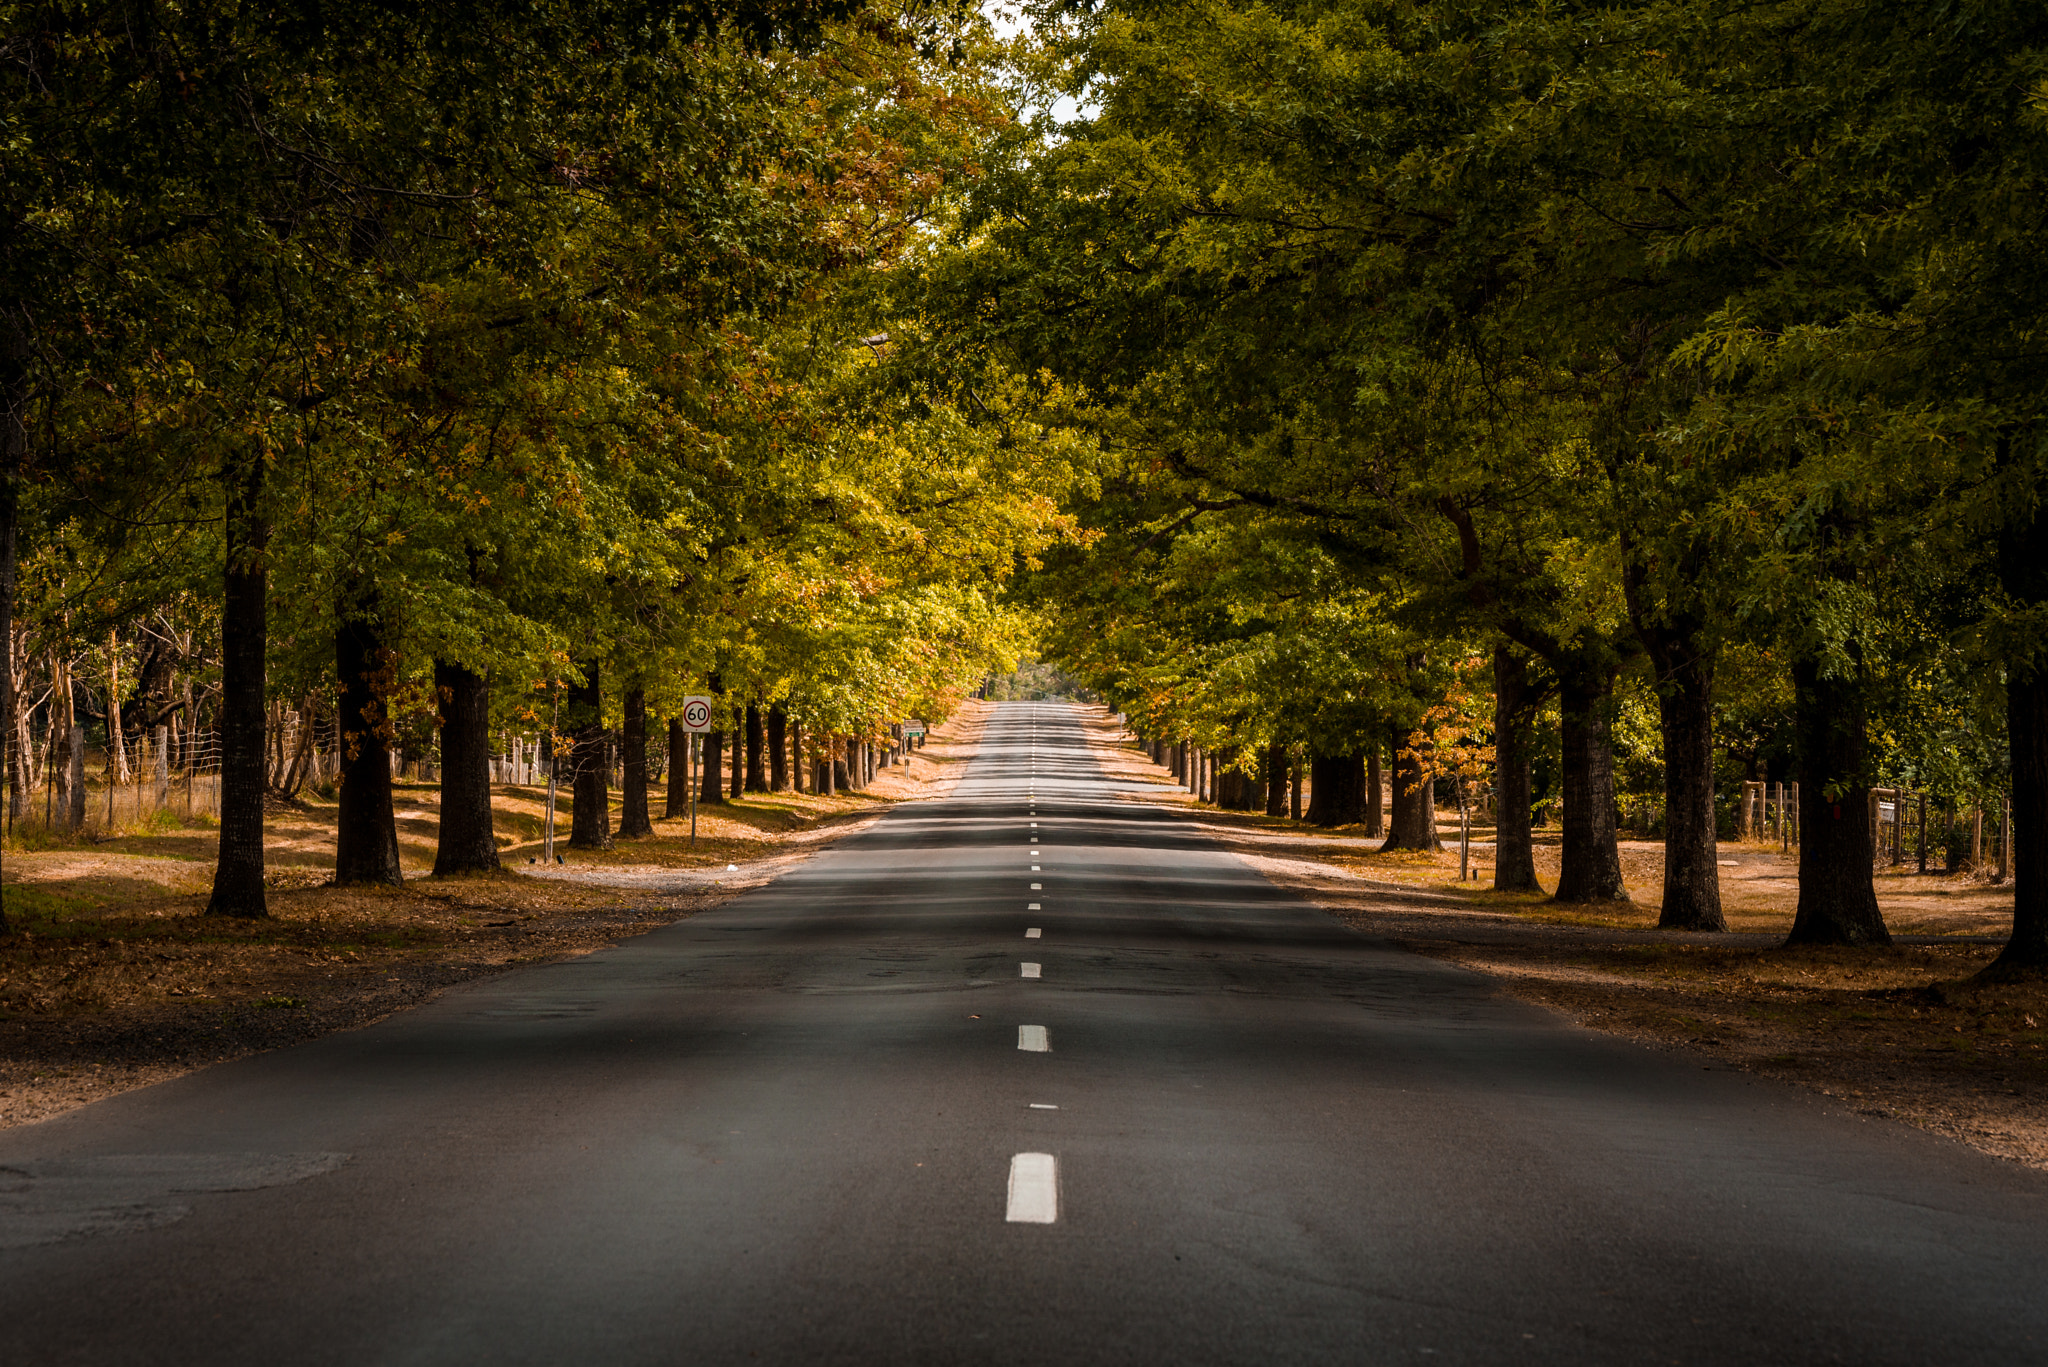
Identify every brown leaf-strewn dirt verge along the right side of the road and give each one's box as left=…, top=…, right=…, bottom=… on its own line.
left=1094, top=719, right=2048, bottom=1168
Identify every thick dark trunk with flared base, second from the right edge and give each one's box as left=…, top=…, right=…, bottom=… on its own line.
left=1786, top=658, right=1892, bottom=945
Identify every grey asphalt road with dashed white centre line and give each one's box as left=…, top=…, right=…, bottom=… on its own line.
left=0, top=703, right=2048, bottom=1367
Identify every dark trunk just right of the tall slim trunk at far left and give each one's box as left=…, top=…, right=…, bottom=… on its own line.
left=334, top=584, right=406, bottom=887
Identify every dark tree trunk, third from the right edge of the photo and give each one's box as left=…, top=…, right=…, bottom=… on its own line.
left=1651, top=635, right=1729, bottom=930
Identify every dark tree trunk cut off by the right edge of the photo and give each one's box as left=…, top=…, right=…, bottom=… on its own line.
left=1982, top=498, right=2048, bottom=980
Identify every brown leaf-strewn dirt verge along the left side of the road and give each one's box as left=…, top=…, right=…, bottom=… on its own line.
left=0, top=703, right=989, bottom=1125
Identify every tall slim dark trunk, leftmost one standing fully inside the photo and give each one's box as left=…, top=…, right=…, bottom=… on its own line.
left=207, top=451, right=270, bottom=916
